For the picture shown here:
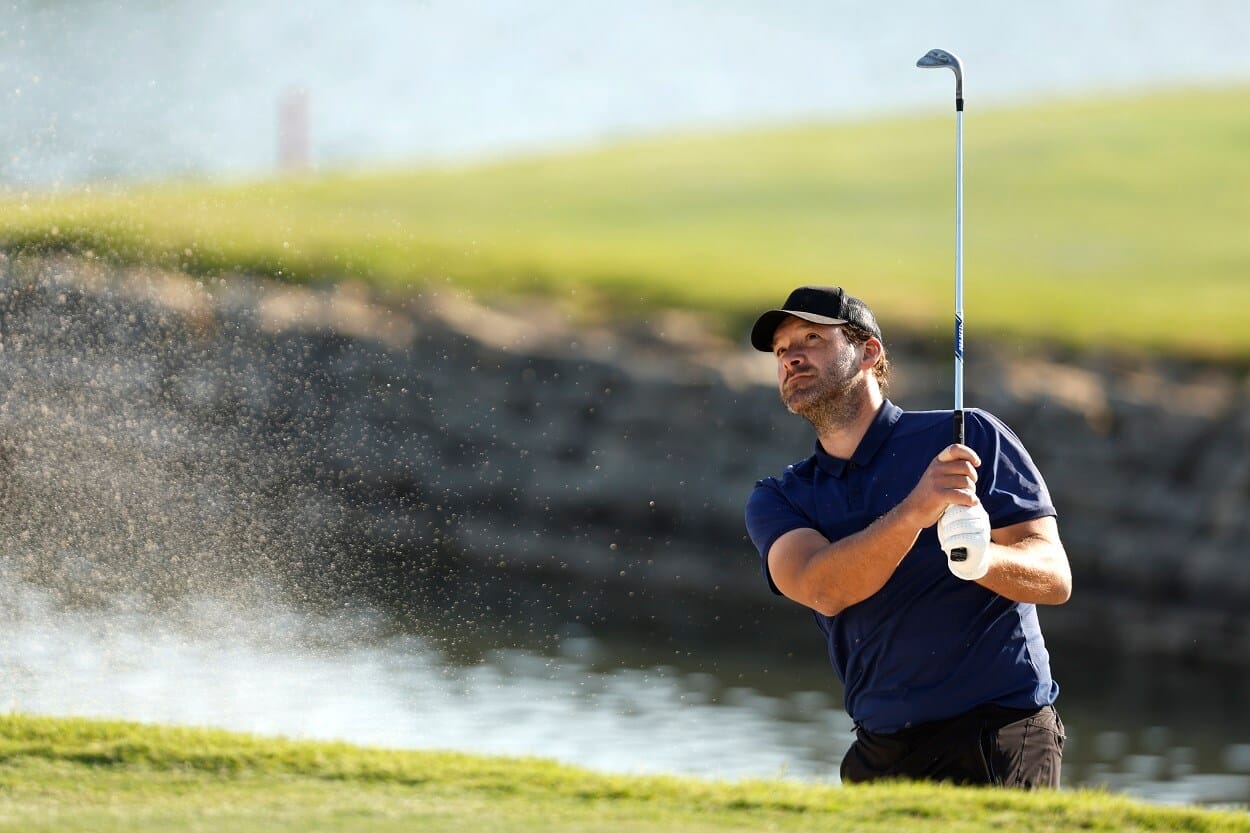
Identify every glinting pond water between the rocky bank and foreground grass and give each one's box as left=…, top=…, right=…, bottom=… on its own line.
left=0, top=584, right=1250, bottom=804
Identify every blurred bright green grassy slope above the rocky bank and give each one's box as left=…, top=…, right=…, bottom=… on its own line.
left=0, top=88, right=1250, bottom=360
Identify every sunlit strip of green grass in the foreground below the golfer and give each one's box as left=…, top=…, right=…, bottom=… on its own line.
left=0, top=714, right=1250, bottom=833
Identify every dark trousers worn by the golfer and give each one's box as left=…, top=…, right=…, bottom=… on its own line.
left=841, top=705, right=1064, bottom=789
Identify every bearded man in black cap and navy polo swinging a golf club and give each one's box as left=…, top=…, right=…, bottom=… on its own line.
left=746, top=286, right=1071, bottom=788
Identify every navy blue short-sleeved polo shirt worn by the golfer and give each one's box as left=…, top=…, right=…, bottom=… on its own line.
left=746, top=400, right=1059, bottom=732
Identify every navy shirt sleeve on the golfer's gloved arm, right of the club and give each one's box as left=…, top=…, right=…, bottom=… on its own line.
left=966, top=409, right=1058, bottom=529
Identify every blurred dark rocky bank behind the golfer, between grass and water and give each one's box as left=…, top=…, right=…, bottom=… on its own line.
left=0, top=252, right=1250, bottom=664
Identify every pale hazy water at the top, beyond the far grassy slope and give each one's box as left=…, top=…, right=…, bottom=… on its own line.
left=7, top=0, right=1250, bottom=186
